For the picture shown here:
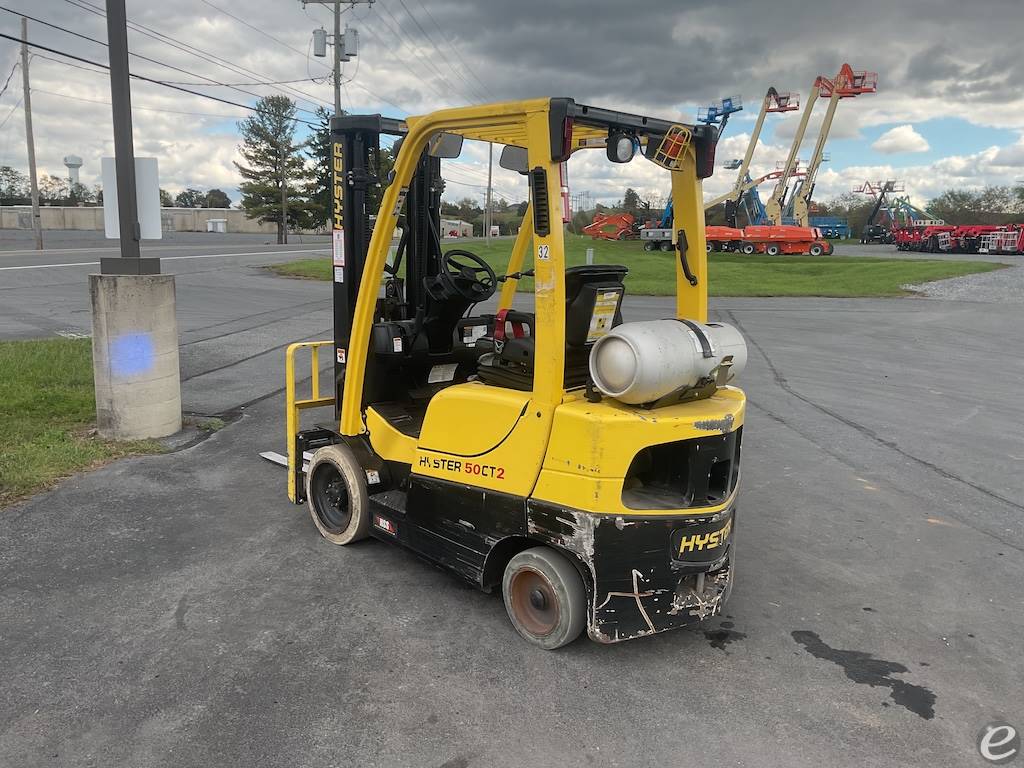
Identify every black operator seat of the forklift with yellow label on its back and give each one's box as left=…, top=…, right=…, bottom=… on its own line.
left=476, top=264, right=629, bottom=391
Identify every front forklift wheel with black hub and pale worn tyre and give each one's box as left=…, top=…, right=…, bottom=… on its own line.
left=306, top=444, right=370, bottom=545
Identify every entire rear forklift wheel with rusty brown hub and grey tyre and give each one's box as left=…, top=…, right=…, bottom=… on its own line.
left=502, top=547, right=587, bottom=650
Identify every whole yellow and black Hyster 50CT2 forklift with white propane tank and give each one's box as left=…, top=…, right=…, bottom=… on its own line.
left=281, top=98, right=746, bottom=649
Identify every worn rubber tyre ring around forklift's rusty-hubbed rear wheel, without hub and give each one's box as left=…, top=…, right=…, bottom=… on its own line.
left=502, top=547, right=587, bottom=650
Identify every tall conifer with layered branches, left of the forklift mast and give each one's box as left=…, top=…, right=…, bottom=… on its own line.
left=234, top=96, right=317, bottom=243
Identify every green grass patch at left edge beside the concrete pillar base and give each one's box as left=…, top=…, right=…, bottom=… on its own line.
left=0, top=339, right=162, bottom=507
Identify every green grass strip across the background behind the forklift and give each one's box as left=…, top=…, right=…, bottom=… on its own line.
left=269, top=234, right=1002, bottom=297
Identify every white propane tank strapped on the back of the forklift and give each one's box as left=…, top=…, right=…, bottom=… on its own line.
left=590, top=319, right=746, bottom=404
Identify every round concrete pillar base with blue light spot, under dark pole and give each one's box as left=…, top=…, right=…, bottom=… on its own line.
left=89, top=274, right=181, bottom=440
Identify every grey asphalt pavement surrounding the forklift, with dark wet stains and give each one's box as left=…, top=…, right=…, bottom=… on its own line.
left=0, top=231, right=1024, bottom=768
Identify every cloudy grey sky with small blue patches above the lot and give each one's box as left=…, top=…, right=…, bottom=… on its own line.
left=0, top=0, right=1024, bottom=210
